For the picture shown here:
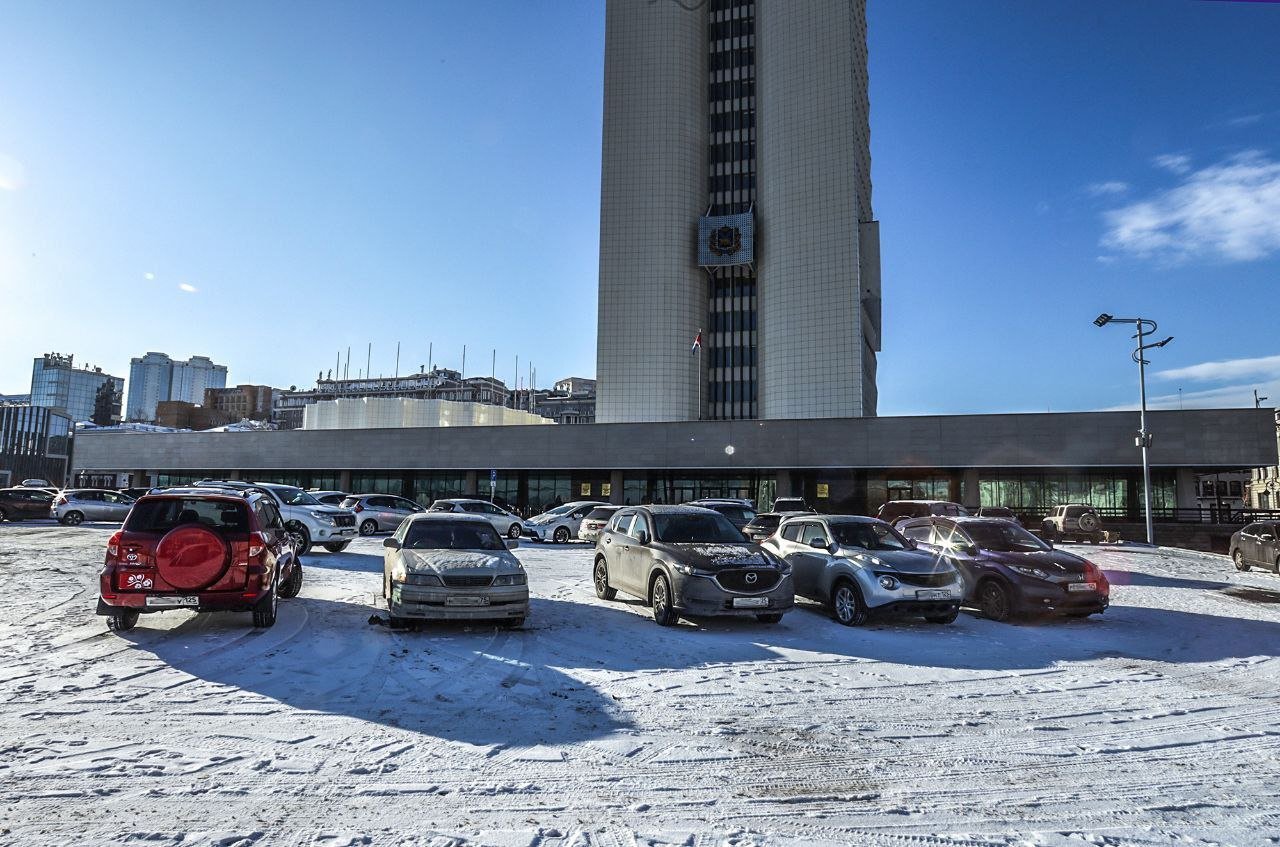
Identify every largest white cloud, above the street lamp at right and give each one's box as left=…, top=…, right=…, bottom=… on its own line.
left=1102, top=150, right=1280, bottom=262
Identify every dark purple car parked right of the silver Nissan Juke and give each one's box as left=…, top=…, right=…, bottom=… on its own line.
left=899, top=517, right=1111, bottom=621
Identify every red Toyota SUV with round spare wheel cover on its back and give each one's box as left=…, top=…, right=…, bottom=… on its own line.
left=97, top=489, right=302, bottom=632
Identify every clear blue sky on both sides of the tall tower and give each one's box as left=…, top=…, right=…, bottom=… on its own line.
left=0, top=0, right=1280, bottom=415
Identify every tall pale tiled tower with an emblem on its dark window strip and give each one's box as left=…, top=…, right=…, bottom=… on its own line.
left=596, top=0, right=879, bottom=422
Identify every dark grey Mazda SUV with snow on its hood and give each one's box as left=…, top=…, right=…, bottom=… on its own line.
left=593, top=505, right=795, bottom=627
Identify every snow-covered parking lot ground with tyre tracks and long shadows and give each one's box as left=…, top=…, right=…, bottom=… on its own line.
left=0, top=523, right=1280, bottom=847
